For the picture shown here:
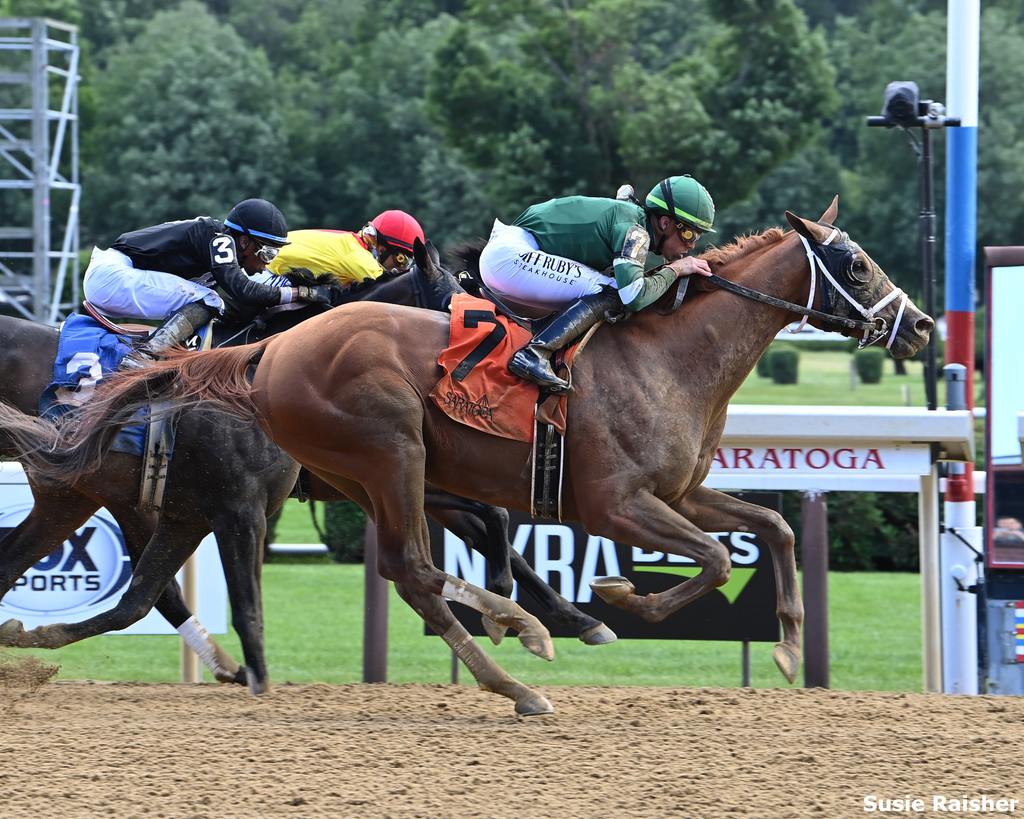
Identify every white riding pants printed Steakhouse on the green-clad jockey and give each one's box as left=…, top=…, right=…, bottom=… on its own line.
left=480, top=219, right=615, bottom=309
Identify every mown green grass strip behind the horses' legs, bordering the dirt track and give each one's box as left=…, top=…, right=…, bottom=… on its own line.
left=18, top=563, right=922, bottom=691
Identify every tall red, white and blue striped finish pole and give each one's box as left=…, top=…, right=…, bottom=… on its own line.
left=939, top=0, right=982, bottom=694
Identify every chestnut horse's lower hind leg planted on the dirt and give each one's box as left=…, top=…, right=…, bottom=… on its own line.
left=394, top=583, right=554, bottom=717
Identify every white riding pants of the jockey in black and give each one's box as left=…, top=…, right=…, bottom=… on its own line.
left=82, top=248, right=224, bottom=318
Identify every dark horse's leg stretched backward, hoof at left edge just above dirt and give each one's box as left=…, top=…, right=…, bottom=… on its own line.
left=0, top=521, right=209, bottom=648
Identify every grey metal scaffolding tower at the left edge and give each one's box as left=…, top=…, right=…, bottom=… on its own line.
left=0, top=17, right=82, bottom=324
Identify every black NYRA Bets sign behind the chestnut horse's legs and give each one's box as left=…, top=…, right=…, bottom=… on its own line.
left=430, top=492, right=781, bottom=642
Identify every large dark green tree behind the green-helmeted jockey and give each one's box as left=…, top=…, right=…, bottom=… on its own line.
left=428, top=0, right=834, bottom=216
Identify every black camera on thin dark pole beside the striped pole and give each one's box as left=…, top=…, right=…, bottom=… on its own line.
left=866, top=80, right=961, bottom=410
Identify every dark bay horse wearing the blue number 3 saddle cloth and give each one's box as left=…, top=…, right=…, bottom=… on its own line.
left=0, top=264, right=614, bottom=708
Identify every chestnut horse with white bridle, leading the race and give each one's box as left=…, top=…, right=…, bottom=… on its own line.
left=0, top=198, right=934, bottom=708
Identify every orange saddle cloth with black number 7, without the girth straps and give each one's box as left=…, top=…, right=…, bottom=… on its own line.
left=430, top=294, right=570, bottom=443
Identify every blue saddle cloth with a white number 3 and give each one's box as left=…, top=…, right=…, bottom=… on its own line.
left=39, top=313, right=145, bottom=456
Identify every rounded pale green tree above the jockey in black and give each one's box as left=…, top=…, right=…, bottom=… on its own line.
left=84, top=2, right=296, bottom=241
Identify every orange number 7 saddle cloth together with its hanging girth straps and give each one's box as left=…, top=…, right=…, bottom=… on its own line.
left=430, top=294, right=589, bottom=519
